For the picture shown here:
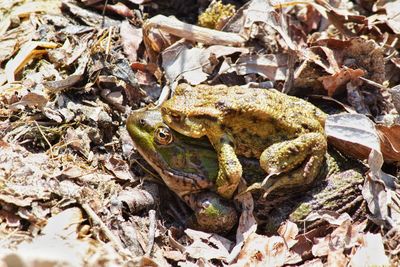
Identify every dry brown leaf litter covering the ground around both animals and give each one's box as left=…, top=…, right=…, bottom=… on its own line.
left=0, top=0, right=400, bottom=266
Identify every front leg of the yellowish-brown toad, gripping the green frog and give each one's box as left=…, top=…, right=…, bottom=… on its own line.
left=210, top=133, right=242, bottom=199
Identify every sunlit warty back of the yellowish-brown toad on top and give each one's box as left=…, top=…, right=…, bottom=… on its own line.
left=177, top=85, right=326, bottom=135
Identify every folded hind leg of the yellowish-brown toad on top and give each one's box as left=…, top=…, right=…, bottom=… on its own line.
left=260, top=132, right=327, bottom=196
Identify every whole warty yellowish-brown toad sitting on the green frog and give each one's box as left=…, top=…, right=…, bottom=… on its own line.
left=161, top=83, right=327, bottom=199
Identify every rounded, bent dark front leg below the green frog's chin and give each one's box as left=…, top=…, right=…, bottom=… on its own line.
left=184, top=191, right=238, bottom=233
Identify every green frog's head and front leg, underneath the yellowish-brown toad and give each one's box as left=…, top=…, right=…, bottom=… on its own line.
left=127, top=109, right=237, bottom=232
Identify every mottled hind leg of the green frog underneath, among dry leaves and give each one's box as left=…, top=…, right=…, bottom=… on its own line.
left=257, top=149, right=366, bottom=233
